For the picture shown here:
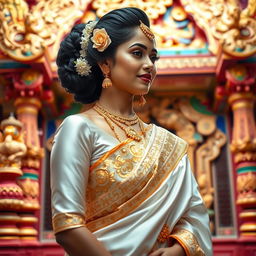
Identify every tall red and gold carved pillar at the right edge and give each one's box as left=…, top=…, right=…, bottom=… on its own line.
left=226, top=65, right=256, bottom=237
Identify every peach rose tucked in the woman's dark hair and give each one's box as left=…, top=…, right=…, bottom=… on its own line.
left=91, top=28, right=111, bottom=52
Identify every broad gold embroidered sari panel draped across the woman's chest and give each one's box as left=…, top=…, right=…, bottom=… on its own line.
left=86, top=127, right=187, bottom=232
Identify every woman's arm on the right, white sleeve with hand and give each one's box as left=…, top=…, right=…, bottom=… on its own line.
left=150, top=156, right=212, bottom=256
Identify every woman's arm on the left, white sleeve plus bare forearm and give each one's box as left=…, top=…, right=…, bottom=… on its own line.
left=51, top=115, right=110, bottom=256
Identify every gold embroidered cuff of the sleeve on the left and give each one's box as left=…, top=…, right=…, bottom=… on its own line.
left=52, top=213, right=85, bottom=234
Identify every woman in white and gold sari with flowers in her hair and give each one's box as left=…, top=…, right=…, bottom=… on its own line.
left=51, top=8, right=212, bottom=256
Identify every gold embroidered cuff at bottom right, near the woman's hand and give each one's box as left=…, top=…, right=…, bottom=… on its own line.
left=170, top=229, right=205, bottom=256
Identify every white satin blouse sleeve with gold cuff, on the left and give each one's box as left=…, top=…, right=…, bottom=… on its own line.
left=50, top=115, right=92, bottom=233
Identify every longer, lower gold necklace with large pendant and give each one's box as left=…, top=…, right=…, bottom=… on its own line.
left=93, top=105, right=145, bottom=142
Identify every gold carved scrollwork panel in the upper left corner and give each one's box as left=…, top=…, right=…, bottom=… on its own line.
left=0, top=0, right=90, bottom=61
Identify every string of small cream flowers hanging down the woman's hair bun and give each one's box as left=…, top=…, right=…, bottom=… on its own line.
left=75, top=21, right=97, bottom=76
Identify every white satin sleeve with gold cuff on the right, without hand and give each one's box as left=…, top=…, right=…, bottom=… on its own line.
left=170, top=155, right=212, bottom=256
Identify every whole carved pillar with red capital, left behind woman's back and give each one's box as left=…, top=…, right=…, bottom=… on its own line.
left=11, top=70, right=43, bottom=242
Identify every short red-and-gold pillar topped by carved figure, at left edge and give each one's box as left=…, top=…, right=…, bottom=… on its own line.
left=0, top=116, right=27, bottom=244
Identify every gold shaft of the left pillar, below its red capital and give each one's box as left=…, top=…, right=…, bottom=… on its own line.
left=15, top=97, right=43, bottom=241
